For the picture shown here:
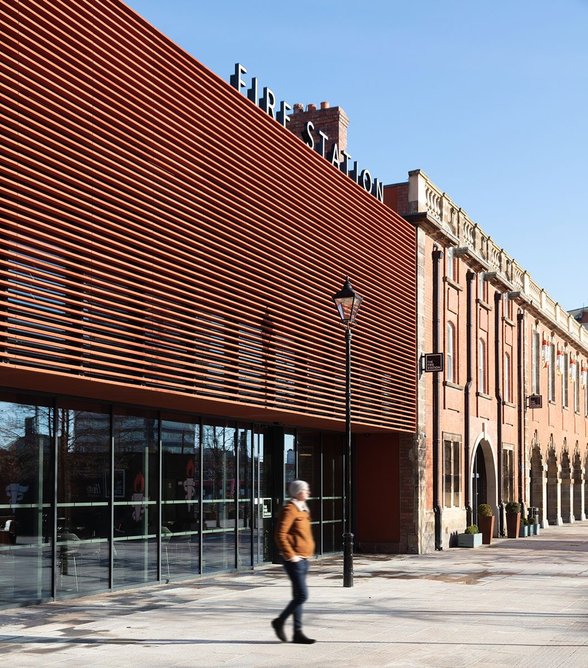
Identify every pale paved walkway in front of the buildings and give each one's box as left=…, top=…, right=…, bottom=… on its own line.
left=0, top=521, right=588, bottom=668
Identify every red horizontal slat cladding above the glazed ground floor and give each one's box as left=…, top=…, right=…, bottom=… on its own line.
left=0, top=0, right=416, bottom=431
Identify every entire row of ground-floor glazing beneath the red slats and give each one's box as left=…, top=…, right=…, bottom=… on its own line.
left=0, top=392, right=343, bottom=606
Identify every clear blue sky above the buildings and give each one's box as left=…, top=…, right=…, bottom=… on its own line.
left=127, top=0, right=588, bottom=309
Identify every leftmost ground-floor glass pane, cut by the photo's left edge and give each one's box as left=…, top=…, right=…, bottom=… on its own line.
left=0, top=401, right=54, bottom=605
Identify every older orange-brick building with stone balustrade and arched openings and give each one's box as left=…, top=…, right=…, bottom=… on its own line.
left=384, top=170, right=588, bottom=550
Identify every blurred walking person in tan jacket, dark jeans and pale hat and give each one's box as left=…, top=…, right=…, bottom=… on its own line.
left=272, top=480, right=315, bottom=645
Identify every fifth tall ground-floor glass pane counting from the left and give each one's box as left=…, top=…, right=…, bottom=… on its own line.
left=202, top=424, right=236, bottom=573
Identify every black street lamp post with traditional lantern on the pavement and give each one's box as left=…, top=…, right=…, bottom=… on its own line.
left=333, top=277, right=363, bottom=587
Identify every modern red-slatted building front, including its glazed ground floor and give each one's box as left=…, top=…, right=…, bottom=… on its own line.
left=0, top=0, right=417, bottom=605
